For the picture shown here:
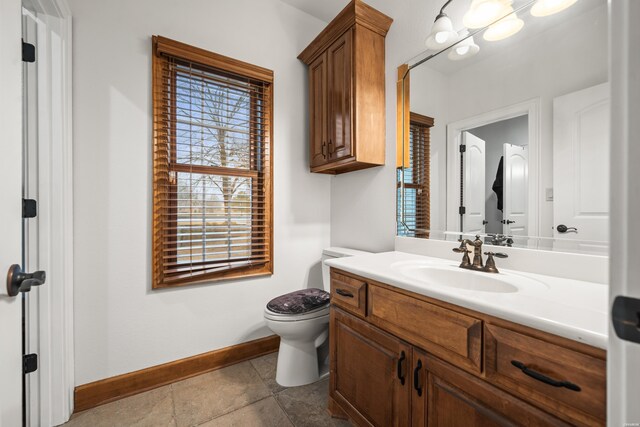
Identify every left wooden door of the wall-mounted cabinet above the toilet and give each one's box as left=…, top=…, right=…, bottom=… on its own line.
left=309, top=53, right=329, bottom=167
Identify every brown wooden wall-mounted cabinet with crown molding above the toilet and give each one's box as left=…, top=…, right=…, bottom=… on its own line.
left=298, top=0, right=392, bottom=174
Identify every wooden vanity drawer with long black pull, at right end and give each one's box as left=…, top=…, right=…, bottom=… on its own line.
left=485, top=325, right=606, bottom=425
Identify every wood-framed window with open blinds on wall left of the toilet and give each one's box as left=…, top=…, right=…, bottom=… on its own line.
left=153, top=36, right=273, bottom=288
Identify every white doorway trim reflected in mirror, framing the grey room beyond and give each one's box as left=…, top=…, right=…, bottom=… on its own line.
left=445, top=98, right=541, bottom=236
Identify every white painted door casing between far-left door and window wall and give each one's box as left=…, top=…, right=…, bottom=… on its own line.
left=22, top=0, right=75, bottom=426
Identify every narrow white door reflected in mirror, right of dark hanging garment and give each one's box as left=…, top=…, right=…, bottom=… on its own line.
left=502, top=144, right=529, bottom=236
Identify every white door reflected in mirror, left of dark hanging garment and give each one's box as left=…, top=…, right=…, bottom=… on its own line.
left=462, top=132, right=486, bottom=234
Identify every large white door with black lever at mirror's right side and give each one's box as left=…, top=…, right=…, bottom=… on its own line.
left=553, top=83, right=610, bottom=242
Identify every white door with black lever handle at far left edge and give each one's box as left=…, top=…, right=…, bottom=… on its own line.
left=0, top=0, right=22, bottom=427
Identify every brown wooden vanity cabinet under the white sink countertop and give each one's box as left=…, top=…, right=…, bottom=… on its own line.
left=329, top=268, right=606, bottom=427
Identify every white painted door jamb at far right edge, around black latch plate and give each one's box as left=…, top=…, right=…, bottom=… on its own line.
left=607, top=0, right=640, bottom=427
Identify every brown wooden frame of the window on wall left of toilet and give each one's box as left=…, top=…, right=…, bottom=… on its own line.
left=152, top=36, right=274, bottom=289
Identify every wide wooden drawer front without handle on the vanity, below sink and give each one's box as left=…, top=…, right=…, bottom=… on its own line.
left=367, top=284, right=482, bottom=372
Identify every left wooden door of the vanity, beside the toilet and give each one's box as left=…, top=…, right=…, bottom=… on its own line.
left=329, top=308, right=411, bottom=427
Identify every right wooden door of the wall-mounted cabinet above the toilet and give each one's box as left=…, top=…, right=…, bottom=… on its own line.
left=327, top=29, right=353, bottom=161
